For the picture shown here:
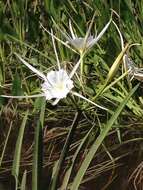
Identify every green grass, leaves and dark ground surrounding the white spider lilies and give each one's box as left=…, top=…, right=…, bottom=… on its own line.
left=0, top=0, right=143, bottom=190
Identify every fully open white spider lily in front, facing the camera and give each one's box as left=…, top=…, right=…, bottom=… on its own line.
left=0, top=53, right=107, bottom=110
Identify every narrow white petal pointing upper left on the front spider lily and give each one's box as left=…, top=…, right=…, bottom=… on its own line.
left=15, top=53, right=47, bottom=81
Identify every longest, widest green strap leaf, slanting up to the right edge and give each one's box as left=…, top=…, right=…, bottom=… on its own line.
left=70, top=84, right=139, bottom=190
